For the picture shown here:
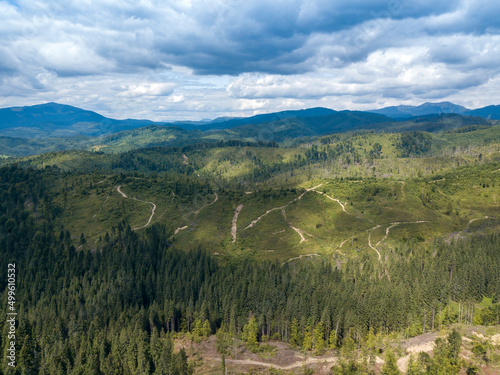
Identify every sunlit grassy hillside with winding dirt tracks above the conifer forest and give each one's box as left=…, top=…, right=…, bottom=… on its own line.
left=5, top=126, right=500, bottom=260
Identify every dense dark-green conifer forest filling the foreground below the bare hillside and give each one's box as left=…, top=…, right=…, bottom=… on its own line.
left=0, top=166, right=500, bottom=374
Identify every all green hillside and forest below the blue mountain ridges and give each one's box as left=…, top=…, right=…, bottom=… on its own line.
left=0, top=119, right=500, bottom=374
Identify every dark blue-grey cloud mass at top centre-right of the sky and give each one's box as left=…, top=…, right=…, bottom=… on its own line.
left=149, top=0, right=460, bottom=75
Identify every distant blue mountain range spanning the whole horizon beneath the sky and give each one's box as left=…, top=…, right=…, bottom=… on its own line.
left=0, top=102, right=500, bottom=139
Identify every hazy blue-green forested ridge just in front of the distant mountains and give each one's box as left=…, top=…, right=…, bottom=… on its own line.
left=0, top=111, right=497, bottom=157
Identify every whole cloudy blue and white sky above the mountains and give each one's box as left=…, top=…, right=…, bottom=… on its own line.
left=0, top=0, right=500, bottom=121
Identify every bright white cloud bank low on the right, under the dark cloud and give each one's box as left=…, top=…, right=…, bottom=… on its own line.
left=227, top=42, right=500, bottom=102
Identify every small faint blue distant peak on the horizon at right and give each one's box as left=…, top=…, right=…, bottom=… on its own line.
left=368, top=102, right=469, bottom=118
